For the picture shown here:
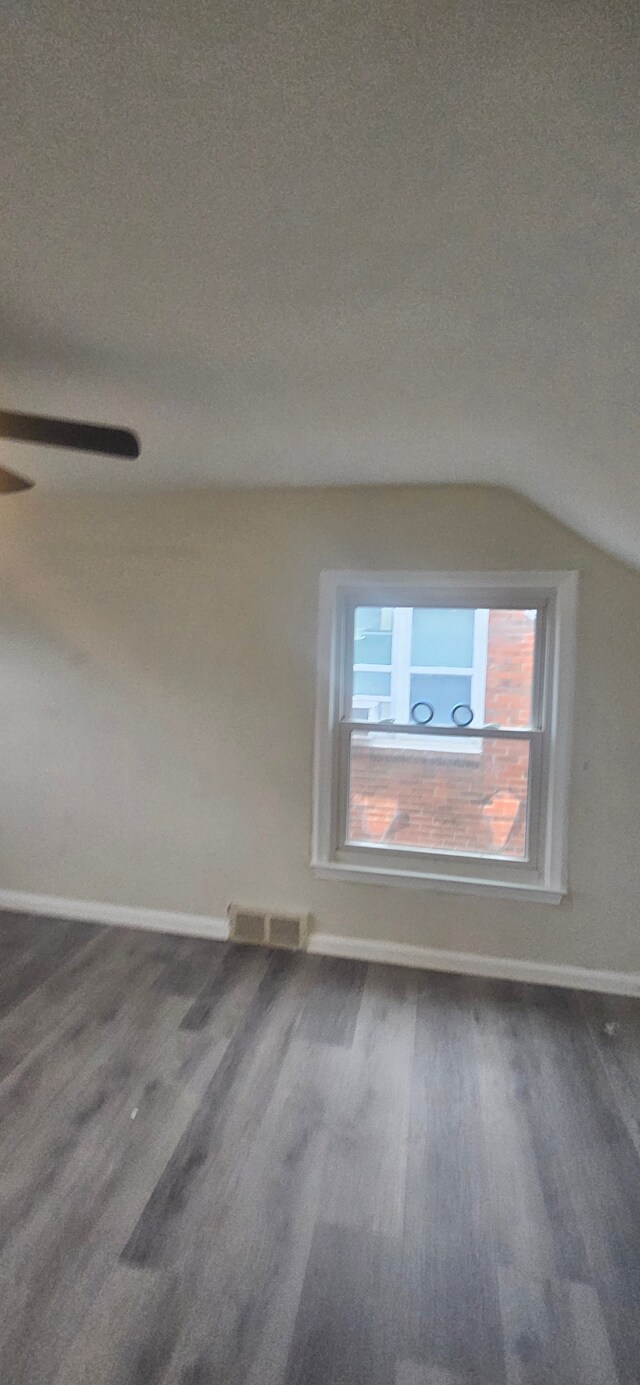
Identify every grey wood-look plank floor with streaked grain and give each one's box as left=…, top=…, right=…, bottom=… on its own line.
left=0, top=914, right=640, bottom=1385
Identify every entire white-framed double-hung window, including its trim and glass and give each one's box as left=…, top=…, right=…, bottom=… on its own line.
left=313, top=572, right=576, bottom=902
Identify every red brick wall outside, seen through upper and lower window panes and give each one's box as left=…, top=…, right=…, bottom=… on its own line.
left=349, top=611, right=535, bottom=857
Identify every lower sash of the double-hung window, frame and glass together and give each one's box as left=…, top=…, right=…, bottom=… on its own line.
left=334, top=723, right=543, bottom=877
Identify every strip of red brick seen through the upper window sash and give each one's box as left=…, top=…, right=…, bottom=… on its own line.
left=485, top=609, right=537, bottom=726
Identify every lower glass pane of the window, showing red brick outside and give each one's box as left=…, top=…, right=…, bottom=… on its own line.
left=348, top=731, right=529, bottom=860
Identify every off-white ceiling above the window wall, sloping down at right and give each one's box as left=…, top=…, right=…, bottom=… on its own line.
left=0, top=0, right=640, bottom=562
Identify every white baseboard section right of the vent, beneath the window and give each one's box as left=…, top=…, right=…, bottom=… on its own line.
left=309, top=933, right=640, bottom=996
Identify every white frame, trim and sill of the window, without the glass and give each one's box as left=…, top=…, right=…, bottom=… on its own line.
left=312, top=572, right=578, bottom=903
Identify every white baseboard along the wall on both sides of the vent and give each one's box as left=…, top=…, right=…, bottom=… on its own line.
left=0, top=889, right=640, bottom=996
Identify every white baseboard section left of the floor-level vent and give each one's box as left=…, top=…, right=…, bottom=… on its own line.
left=0, top=889, right=229, bottom=940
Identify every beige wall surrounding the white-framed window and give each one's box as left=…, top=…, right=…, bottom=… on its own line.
left=0, top=486, right=640, bottom=970
